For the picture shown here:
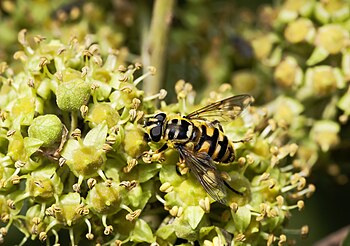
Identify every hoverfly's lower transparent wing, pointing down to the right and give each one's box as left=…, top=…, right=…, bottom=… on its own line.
left=176, top=145, right=226, bottom=204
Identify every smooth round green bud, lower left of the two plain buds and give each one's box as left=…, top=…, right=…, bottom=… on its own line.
left=28, top=114, right=63, bottom=147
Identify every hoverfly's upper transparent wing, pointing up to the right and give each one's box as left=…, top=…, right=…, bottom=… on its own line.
left=186, top=94, right=254, bottom=119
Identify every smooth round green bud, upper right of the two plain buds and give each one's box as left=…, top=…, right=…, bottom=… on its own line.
left=56, top=79, right=90, bottom=111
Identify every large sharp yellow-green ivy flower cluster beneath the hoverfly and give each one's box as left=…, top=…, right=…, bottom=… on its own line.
left=0, top=30, right=312, bottom=245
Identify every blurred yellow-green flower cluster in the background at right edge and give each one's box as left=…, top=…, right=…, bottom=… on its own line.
left=246, top=0, right=350, bottom=184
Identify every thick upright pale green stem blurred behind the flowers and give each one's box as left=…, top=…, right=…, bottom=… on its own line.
left=142, top=0, right=175, bottom=95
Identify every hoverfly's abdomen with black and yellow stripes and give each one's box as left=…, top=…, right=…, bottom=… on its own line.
left=191, top=121, right=235, bottom=163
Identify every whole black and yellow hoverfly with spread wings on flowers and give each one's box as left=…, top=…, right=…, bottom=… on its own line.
left=145, top=94, right=253, bottom=204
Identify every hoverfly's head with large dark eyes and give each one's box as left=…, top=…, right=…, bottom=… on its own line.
left=145, top=113, right=166, bottom=142
